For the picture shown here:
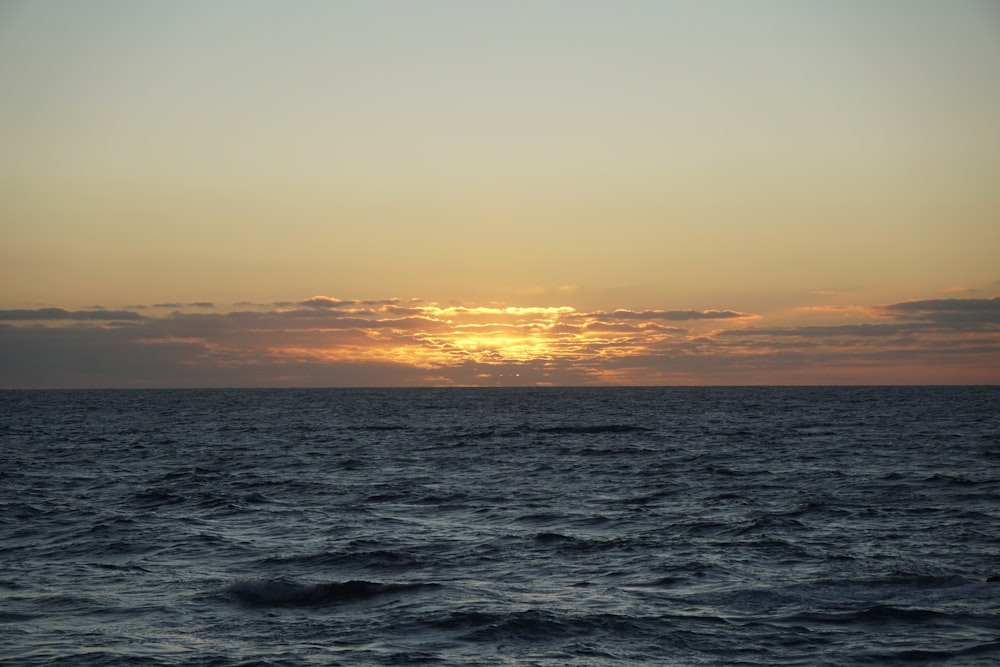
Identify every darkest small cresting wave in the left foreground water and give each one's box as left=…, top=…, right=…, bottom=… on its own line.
left=223, top=579, right=439, bottom=607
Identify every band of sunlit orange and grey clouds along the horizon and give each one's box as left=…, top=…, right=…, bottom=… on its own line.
left=0, top=296, right=1000, bottom=388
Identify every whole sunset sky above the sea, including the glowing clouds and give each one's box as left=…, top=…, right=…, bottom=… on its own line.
left=0, top=0, right=1000, bottom=388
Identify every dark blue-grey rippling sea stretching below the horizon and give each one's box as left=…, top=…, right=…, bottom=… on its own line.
left=0, top=387, right=1000, bottom=666
